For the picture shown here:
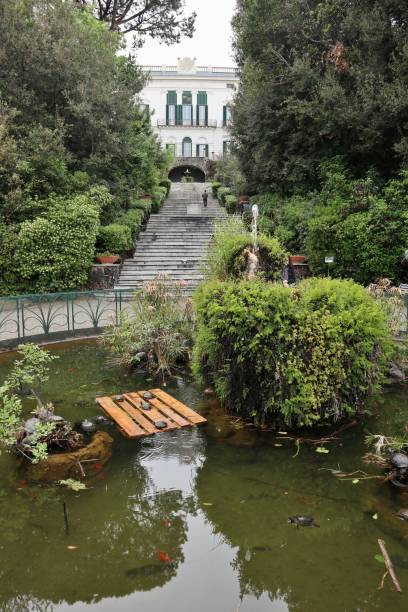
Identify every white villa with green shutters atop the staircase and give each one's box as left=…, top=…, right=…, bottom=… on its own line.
left=141, top=58, right=238, bottom=179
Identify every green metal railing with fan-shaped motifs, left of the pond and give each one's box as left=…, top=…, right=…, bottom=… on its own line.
left=0, top=289, right=135, bottom=345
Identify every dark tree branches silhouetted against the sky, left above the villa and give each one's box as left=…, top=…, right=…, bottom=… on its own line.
left=78, top=0, right=196, bottom=44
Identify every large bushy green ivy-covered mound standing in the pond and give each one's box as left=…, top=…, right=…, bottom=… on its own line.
left=193, top=279, right=392, bottom=427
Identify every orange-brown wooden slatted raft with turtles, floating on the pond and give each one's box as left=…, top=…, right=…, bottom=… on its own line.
left=96, top=389, right=207, bottom=438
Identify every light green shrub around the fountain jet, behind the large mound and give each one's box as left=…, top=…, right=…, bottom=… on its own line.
left=205, top=217, right=287, bottom=281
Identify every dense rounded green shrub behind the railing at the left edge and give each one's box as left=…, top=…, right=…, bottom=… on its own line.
left=0, top=194, right=99, bottom=293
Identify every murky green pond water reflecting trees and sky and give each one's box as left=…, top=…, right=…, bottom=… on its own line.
left=0, top=342, right=408, bottom=612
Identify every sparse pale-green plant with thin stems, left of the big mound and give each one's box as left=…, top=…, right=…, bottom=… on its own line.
left=102, top=275, right=193, bottom=376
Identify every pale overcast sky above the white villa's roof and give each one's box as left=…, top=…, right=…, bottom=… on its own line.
left=132, top=0, right=235, bottom=66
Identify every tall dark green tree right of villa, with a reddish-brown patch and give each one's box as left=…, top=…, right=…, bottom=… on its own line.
left=233, top=0, right=408, bottom=192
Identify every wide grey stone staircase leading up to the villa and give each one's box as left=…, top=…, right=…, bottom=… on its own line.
left=117, top=183, right=227, bottom=293
